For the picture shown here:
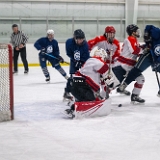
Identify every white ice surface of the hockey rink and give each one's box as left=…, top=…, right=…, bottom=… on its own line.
left=0, top=67, right=160, bottom=160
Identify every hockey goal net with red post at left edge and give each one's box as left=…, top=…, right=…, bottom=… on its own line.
left=0, top=44, right=13, bottom=122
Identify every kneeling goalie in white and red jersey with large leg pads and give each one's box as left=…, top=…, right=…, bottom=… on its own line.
left=64, top=48, right=119, bottom=118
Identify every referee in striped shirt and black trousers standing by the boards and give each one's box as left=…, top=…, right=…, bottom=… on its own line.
left=11, top=24, right=29, bottom=74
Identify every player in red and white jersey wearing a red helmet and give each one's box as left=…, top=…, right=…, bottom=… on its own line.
left=88, top=26, right=120, bottom=66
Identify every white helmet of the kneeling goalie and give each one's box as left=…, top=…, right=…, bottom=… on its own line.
left=90, top=46, right=108, bottom=61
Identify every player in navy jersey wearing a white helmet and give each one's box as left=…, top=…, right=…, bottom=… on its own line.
left=34, top=29, right=68, bottom=82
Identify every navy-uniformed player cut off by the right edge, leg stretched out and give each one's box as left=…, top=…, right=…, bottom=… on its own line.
left=119, top=25, right=160, bottom=97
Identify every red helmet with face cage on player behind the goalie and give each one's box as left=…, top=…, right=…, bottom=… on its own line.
left=105, top=26, right=116, bottom=43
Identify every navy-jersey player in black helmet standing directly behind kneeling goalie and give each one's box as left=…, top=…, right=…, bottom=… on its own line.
left=63, top=29, right=89, bottom=99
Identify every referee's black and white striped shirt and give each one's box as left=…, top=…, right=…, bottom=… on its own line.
left=11, top=31, right=28, bottom=47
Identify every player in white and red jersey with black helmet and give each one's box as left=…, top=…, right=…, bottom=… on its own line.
left=113, top=24, right=145, bottom=103
